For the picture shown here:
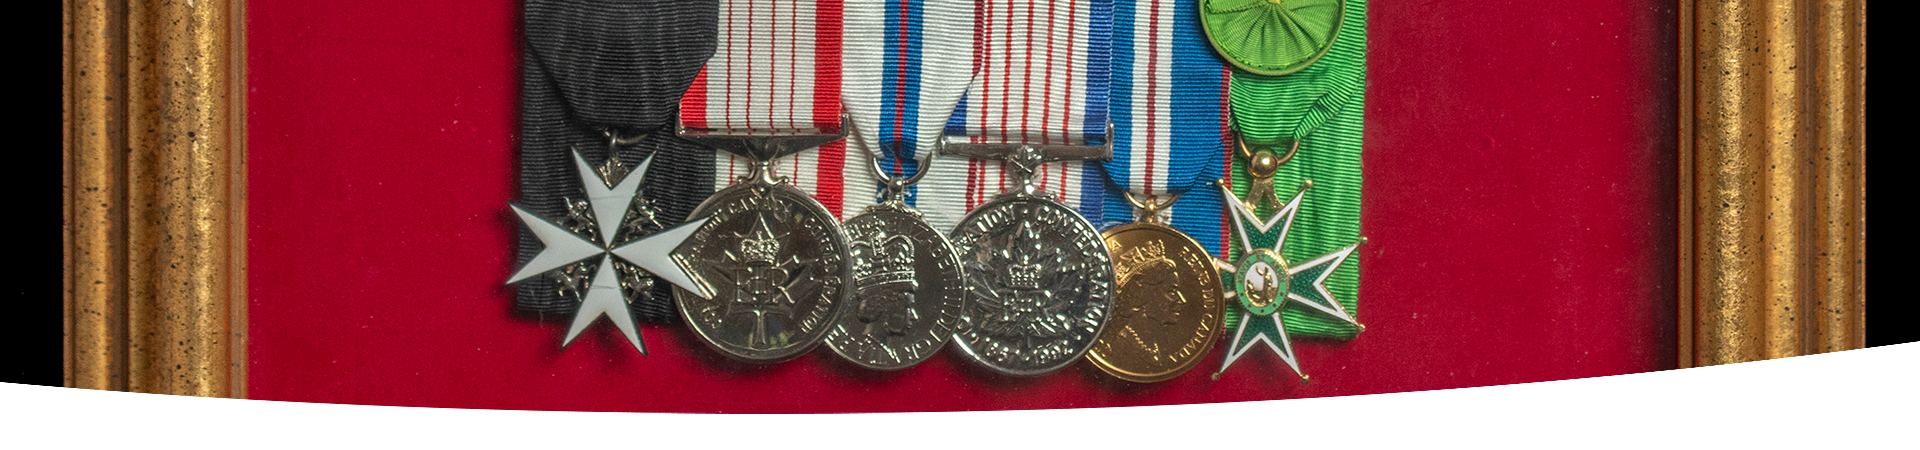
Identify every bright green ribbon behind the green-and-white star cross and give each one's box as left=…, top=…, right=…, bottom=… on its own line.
left=1227, top=0, right=1367, bottom=338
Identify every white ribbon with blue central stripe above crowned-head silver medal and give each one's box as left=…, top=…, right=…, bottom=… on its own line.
left=841, top=0, right=973, bottom=201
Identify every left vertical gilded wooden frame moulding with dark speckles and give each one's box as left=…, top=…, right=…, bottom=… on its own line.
left=61, top=0, right=246, bottom=398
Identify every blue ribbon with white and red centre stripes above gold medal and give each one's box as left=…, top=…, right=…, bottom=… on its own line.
left=1083, top=0, right=1233, bottom=254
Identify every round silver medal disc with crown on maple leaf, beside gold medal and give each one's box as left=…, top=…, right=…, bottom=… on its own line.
left=950, top=194, right=1114, bottom=375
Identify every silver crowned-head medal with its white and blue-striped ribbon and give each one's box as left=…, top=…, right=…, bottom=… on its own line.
left=816, top=0, right=973, bottom=371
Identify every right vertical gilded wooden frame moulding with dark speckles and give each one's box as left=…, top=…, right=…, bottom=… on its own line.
left=1678, top=0, right=1866, bottom=369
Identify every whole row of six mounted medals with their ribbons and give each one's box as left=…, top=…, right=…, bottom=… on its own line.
left=507, top=0, right=1365, bottom=383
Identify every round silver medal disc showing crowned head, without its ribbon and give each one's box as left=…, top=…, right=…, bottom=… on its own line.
left=828, top=202, right=966, bottom=371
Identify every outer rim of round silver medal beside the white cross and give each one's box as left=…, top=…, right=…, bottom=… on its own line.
left=674, top=183, right=852, bottom=363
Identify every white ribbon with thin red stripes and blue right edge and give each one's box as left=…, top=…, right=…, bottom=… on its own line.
left=916, top=0, right=1114, bottom=229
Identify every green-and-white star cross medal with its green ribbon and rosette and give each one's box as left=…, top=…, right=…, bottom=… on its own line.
left=1202, top=0, right=1367, bottom=383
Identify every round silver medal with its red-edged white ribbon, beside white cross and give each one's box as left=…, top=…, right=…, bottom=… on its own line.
left=674, top=0, right=852, bottom=363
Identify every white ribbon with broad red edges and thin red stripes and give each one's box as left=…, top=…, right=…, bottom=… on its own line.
left=680, top=0, right=852, bottom=217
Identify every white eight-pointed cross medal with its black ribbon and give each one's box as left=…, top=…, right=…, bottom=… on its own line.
left=507, top=0, right=716, bottom=356
